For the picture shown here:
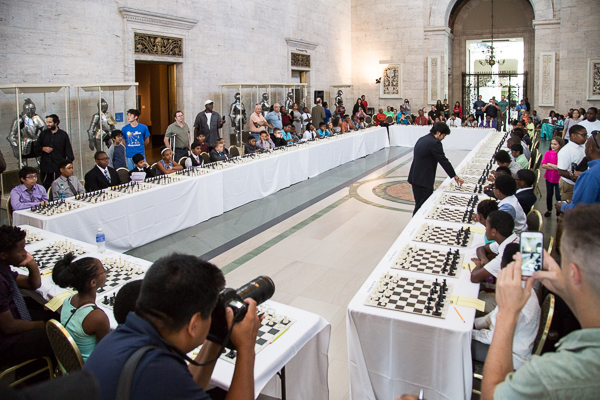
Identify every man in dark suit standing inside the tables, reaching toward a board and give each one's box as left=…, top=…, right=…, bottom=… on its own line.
left=408, top=122, right=464, bottom=215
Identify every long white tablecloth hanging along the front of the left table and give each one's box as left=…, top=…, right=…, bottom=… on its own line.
left=13, top=128, right=389, bottom=252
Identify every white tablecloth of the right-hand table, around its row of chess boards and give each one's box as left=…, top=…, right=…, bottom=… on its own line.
left=346, top=131, right=501, bottom=400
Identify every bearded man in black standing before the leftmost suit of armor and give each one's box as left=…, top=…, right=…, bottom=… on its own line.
left=34, top=114, right=75, bottom=190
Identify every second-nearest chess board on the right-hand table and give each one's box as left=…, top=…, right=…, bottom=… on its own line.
left=392, top=245, right=463, bottom=278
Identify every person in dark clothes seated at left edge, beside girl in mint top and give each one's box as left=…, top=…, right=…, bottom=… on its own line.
left=0, top=227, right=57, bottom=366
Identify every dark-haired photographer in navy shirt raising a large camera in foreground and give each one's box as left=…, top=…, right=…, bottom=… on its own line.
left=84, top=254, right=260, bottom=400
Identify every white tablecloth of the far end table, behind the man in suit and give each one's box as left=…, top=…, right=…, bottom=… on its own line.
left=390, top=125, right=494, bottom=150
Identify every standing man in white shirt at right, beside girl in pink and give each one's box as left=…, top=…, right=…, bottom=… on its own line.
left=556, top=124, right=588, bottom=201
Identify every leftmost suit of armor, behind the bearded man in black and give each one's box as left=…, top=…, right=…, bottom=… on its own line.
left=6, top=99, right=46, bottom=167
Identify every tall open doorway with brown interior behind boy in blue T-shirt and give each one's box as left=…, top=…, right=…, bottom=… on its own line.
left=135, top=61, right=177, bottom=163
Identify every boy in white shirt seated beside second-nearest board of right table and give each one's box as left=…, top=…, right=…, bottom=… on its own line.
left=471, top=210, right=519, bottom=283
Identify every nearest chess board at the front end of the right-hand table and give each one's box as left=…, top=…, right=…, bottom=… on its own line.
left=365, top=273, right=452, bottom=318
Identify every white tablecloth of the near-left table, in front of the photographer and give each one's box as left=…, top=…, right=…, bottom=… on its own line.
left=16, top=225, right=331, bottom=400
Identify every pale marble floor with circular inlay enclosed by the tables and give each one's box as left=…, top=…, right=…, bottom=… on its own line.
left=123, top=148, right=467, bottom=399
